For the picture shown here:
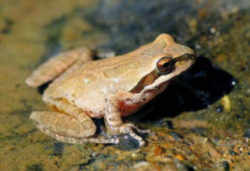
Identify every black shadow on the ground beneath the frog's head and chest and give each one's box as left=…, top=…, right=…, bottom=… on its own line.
left=131, top=57, right=237, bottom=121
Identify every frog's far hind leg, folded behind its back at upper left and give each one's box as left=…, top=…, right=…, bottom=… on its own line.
left=26, top=48, right=94, bottom=87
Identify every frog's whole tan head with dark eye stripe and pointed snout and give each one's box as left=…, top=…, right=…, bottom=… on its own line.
left=132, top=34, right=195, bottom=93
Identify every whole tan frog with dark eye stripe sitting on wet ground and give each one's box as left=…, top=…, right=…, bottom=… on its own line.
left=26, top=33, right=195, bottom=146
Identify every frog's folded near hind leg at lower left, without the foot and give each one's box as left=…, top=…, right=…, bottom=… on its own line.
left=30, top=111, right=96, bottom=141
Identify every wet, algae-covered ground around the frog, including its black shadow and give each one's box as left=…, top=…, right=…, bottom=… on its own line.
left=0, top=0, right=250, bottom=171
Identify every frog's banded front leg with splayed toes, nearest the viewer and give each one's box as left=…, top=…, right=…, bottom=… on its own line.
left=104, top=94, right=149, bottom=146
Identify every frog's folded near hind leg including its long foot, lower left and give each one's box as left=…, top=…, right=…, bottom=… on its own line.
left=30, top=111, right=118, bottom=144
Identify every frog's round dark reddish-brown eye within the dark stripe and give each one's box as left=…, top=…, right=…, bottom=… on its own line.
left=156, top=56, right=175, bottom=75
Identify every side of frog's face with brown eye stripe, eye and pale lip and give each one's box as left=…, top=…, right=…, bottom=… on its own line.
left=130, top=54, right=195, bottom=93
